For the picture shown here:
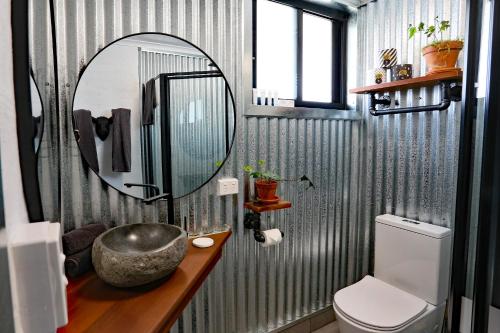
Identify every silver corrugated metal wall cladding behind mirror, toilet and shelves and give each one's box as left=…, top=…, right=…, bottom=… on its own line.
left=28, top=0, right=465, bottom=333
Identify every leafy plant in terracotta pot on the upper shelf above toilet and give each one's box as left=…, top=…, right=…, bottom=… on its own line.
left=408, top=16, right=464, bottom=74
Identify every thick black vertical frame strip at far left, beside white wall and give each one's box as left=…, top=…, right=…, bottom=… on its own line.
left=11, top=0, right=44, bottom=222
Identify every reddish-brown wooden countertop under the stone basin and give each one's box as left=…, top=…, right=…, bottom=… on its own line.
left=57, top=231, right=231, bottom=333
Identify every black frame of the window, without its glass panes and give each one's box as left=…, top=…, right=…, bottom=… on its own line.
left=252, top=0, right=349, bottom=110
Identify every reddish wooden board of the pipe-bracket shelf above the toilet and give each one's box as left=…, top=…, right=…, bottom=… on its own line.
left=349, top=68, right=462, bottom=94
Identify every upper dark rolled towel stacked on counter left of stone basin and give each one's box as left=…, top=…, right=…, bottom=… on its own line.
left=62, top=223, right=106, bottom=256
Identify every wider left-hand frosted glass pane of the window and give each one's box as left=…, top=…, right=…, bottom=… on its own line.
left=257, top=0, right=297, bottom=99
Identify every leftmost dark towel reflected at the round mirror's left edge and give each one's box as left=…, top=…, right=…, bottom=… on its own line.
left=73, top=110, right=99, bottom=172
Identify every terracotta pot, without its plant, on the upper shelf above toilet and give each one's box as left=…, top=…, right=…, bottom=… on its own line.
left=422, top=40, right=464, bottom=74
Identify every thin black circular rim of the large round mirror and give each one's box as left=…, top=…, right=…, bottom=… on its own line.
left=71, top=32, right=237, bottom=217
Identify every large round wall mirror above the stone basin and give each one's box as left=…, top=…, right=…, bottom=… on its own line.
left=73, top=33, right=236, bottom=199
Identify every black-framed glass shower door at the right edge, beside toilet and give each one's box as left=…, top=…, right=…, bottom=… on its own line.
left=451, top=0, right=500, bottom=333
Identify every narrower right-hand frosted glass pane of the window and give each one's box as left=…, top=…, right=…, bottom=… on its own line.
left=302, top=13, right=332, bottom=103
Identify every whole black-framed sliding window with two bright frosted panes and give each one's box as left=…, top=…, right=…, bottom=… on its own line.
left=253, top=0, right=346, bottom=108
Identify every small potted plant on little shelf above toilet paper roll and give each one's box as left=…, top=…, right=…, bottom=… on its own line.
left=243, top=160, right=314, bottom=204
